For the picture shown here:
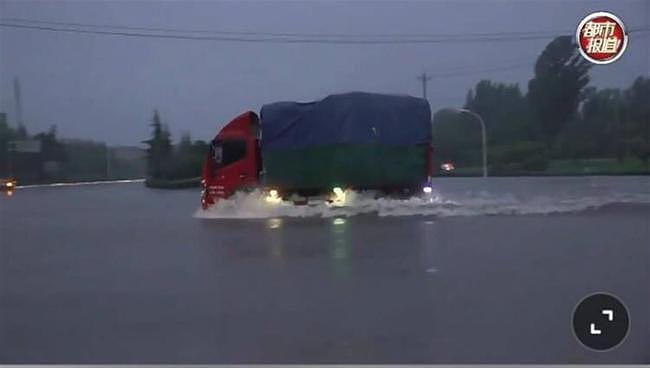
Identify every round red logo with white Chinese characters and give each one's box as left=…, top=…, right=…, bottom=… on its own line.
left=576, top=12, right=627, bottom=64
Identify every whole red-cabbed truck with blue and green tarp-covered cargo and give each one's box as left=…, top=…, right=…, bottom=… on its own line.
left=201, top=92, right=432, bottom=209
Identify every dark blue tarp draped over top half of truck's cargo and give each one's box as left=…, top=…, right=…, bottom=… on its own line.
left=260, top=92, right=431, bottom=150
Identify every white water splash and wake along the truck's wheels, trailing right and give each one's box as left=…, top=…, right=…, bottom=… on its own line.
left=194, top=187, right=650, bottom=219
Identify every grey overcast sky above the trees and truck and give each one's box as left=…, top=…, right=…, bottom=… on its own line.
left=0, top=0, right=650, bottom=145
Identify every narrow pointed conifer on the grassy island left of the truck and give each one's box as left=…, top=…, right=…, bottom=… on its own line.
left=144, top=110, right=172, bottom=178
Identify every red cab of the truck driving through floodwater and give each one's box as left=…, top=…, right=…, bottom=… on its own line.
left=201, top=111, right=262, bottom=209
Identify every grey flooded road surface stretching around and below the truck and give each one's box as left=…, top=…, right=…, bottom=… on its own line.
left=0, top=177, right=650, bottom=363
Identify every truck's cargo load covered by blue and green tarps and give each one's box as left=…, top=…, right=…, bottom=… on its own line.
left=261, top=92, right=431, bottom=190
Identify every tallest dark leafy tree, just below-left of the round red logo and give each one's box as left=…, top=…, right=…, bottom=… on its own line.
left=528, top=36, right=592, bottom=148
